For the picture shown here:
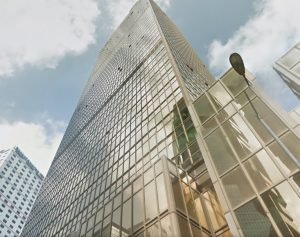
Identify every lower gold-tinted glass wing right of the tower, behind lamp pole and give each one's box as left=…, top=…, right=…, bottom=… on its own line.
left=190, top=70, right=300, bottom=237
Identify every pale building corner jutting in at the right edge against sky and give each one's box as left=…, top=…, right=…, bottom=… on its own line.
left=273, top=42, right=300, bottom=99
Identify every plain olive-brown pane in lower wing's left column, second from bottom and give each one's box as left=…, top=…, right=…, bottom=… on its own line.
left=222, top=167, right=254, bottom=207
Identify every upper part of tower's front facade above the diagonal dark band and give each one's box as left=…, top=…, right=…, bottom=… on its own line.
left=57, top=1, right=161, bottom=157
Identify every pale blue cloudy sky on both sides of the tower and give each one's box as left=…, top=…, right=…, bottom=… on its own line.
left=0, top=0, right=300, bottom=174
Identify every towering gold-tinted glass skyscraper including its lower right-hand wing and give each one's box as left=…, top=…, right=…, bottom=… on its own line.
left=22, top=0, right=300, bottom=237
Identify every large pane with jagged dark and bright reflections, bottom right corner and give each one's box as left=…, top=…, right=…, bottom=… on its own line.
left=262, top=181, right=300, bottom=236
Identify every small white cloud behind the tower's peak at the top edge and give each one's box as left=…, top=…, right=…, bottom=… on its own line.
left=106, top=0, right=171, bottom=29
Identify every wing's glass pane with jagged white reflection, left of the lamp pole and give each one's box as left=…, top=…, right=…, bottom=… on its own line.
left=223, top=114, right=260, bottom=160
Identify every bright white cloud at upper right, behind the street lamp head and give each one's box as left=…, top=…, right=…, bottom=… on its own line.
left=208, top=0, right=300, bottom=108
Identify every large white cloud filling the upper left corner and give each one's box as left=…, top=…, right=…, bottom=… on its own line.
left=0, top=0, right=100, bottom=76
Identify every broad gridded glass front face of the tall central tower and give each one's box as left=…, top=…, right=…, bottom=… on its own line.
left=22, top=0, right=231, bottom=237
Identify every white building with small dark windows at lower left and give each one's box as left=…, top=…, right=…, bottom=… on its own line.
left=0, top=147, right=44, bottom=236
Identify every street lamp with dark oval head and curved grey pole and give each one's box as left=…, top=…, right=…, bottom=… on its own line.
left=229, top=53, right=300, bottom=169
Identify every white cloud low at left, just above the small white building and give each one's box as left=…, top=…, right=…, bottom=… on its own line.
left=0, top=118, right=66, bottom=175
